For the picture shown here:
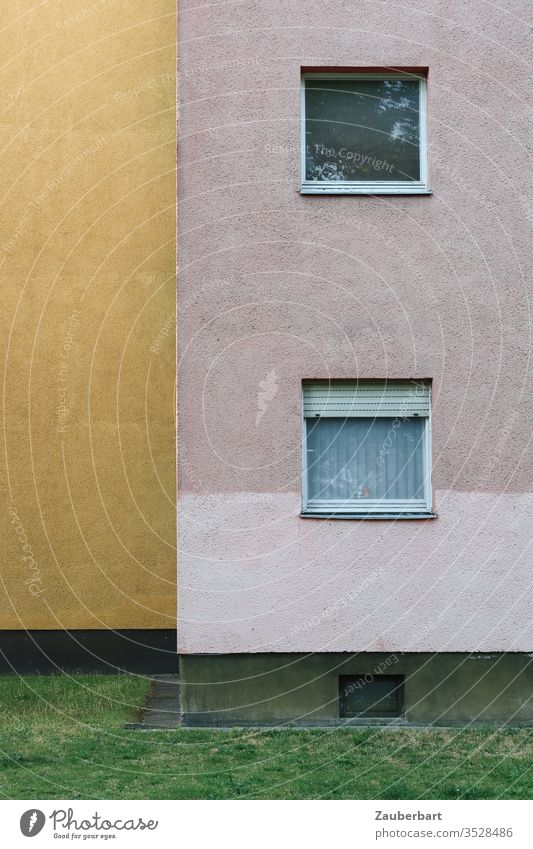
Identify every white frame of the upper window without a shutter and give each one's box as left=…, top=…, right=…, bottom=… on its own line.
left=300, top=71, right=431, bottom=195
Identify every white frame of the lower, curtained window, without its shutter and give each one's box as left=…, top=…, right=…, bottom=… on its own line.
left=301, top=383, right=435, bottom=518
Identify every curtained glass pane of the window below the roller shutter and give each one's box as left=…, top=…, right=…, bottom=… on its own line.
left=306, top=418, right=425, bottom=506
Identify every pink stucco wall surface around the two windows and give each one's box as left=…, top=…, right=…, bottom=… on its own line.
left=178, top=0, right=533, bottom=653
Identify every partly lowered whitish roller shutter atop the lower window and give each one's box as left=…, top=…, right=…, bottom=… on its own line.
left=303, top=380, right=431, bottom=418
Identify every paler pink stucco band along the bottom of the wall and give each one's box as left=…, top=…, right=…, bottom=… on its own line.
left=179, top=490, right=533, bottom=653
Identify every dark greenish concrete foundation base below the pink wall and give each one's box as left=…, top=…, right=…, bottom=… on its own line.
left=180, top=652, right=533, bottom=727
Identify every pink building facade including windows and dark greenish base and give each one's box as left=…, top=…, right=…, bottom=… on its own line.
left=178, top=0, right=533, bottom=725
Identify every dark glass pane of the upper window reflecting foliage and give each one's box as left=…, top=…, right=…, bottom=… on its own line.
left=305, top=79, right=420, bottom=182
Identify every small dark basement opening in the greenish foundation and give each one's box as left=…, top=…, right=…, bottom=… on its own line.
left=339, top=674, right=404, bottom=717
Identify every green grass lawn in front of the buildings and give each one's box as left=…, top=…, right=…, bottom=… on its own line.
left=0, top=675, right=533, bottom=799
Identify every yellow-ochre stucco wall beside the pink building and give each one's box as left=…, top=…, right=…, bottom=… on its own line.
left=0, top=0, right=176, bottom=628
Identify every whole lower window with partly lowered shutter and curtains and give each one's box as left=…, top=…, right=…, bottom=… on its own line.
left=303, top=380, right=432, bottom=516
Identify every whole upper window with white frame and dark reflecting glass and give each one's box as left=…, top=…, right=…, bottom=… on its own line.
left=302, top=73, right=429, bottom=194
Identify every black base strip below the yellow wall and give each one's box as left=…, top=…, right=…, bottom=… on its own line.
left=0, top=629, right=178, bottom=675
